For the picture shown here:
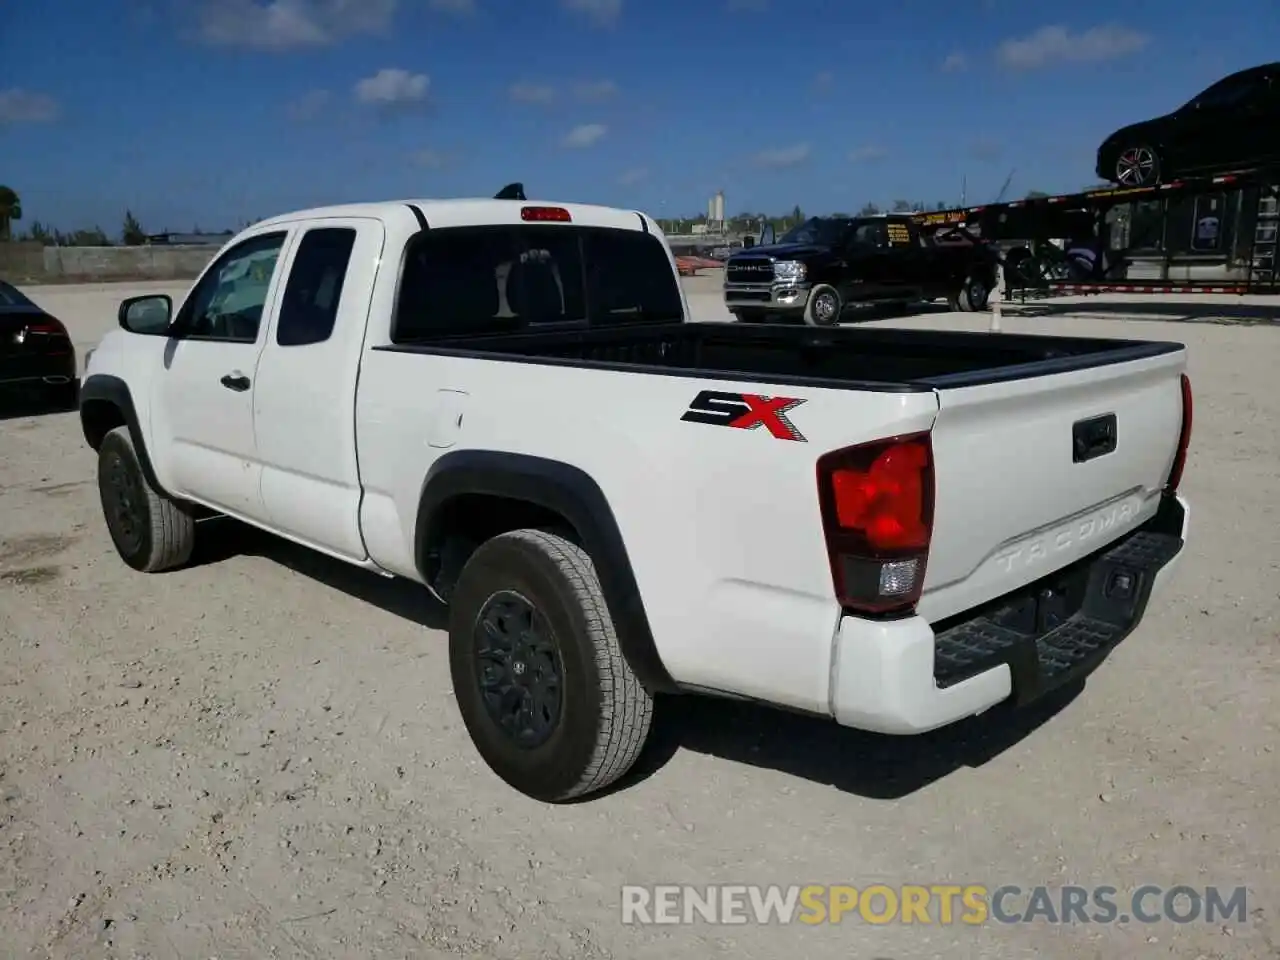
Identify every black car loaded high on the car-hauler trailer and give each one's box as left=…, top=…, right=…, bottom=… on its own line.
left=1096, top=63, right=1280, bottom=187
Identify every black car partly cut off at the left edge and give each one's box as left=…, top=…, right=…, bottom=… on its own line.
left=0, top=280, right=78, bottom=410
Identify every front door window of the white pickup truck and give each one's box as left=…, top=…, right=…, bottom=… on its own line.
left=178, top=232, right=285, bottom=343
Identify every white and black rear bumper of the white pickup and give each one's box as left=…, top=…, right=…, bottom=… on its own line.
left=831, top=497, right=1190, bottom=733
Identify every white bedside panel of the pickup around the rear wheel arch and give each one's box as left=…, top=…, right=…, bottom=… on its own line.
left=356, top=349, right=937, bottom=712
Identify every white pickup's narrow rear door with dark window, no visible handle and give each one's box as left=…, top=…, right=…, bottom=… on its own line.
left=253, top=218, right=385, bottom=561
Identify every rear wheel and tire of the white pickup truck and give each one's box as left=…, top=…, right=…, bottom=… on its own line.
left=449, top=530, right=653, bottom=803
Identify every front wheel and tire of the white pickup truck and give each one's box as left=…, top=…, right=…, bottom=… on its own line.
left=97, top=426, right=196, bottom=573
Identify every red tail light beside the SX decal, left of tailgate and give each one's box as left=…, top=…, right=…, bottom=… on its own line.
left=818, top=433, right=933, bottom=613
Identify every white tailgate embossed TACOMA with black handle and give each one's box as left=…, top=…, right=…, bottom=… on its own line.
left=919, top=349, right=1187, bottom=621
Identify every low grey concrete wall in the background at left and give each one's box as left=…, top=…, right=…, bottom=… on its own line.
left=0, top=243, right=218, bottom=283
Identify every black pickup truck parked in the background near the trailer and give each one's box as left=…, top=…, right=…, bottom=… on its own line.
left=724, top=214, right=997, bottom=326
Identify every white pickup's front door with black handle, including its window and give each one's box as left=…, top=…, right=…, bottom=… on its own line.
left=151, top=229, right=289, bottom=520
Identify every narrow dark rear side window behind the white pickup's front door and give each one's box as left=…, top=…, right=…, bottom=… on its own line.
left=275, top=227, right=356, bottom=347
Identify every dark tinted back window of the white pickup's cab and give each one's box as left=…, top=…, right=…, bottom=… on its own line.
left=392, top=225, right=684, bottom=343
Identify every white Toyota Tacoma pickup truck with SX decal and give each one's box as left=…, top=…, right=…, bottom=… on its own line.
left=81, top=189, right=1192, bottom=801
